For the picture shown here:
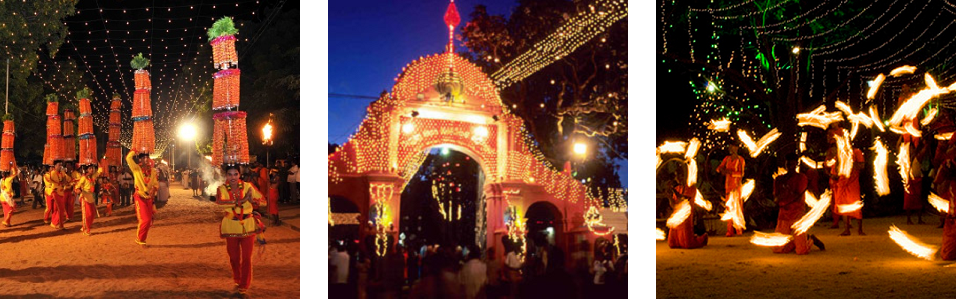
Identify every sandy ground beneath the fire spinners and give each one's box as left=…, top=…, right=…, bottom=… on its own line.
left=656, top=215, right=956, bottom=298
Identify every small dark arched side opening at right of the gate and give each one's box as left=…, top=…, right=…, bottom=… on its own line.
left=525, top=201, right=564, bottom=253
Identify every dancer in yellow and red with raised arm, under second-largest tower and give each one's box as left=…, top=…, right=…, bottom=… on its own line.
left=126, top=150, right=159, bottom=245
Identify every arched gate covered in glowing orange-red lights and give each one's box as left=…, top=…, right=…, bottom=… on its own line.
left=328, top=0, right=597, bottom=255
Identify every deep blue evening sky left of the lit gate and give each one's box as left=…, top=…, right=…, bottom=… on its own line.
left=328, top=0, right=627, bottom=187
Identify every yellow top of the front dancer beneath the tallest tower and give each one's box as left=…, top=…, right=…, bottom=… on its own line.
left=216, top=182, right=267, bottom=238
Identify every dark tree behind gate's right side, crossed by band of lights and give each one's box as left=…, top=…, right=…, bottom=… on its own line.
left=461, top=0, right=627, bottom=197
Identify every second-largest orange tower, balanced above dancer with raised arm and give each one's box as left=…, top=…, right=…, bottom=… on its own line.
left=130, top=53, right=156, bottom=154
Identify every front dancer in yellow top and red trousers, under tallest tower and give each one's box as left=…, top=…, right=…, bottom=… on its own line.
left=216, top=164, right=268, bottom=294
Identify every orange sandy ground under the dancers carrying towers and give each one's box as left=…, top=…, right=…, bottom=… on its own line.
left=0, top=184, right=299, bottom=298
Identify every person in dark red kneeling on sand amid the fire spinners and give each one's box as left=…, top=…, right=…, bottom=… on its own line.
left=773, top=154, right=826, bottom=255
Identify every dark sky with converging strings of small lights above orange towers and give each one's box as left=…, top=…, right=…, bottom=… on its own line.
left=37, top=0, right=278, bottom=154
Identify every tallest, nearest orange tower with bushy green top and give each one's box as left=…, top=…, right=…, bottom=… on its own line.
left=208, top=18, right=249, bottom=165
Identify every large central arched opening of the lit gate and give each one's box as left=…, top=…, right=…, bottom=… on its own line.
left=399, top=145, right=484, bottom=250
